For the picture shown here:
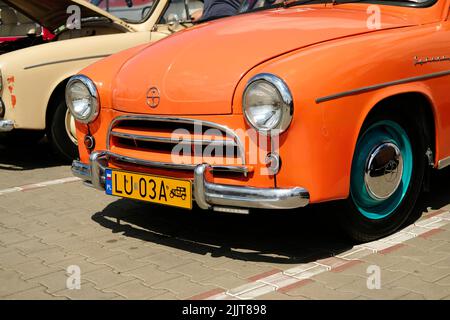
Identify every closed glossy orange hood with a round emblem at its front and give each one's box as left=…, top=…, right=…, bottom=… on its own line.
left=113, top=5, right=411, bottom=115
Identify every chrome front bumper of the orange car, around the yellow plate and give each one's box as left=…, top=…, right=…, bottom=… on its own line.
left=72, top=151, right=309, bottom=212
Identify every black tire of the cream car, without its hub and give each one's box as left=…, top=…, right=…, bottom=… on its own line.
left=47, top=101, right=78, bottom=161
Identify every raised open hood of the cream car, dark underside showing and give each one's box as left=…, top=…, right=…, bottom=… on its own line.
left=3, top=0, right=131, bottom=31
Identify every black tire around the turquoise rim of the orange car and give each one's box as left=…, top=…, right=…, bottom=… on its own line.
left=339, top=109, right=427, bottom=242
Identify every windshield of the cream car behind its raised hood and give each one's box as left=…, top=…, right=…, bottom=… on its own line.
left=90, top=0, right=157, bottom=23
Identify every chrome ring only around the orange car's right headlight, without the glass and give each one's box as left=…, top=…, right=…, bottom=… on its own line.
left=242, top=73, right=294, bottom=136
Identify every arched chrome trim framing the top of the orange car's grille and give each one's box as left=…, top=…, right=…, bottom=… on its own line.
left=106, top=115, right=246, bottom=166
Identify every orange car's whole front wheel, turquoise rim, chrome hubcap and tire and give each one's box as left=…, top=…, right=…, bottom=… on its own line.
left=342, top=116, right=426, bottom=242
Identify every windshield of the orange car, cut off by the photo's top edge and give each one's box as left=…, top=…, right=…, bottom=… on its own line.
left=239, top=0, right=436, bottom=13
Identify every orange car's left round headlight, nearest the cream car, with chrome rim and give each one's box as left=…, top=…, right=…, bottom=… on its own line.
left=66, top=75, right=99, bottom=123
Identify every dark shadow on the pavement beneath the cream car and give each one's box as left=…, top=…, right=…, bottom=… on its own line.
left=0, top=138, right=69, bottom=171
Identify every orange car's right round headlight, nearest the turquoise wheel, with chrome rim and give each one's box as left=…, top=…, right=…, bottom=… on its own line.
left=242, top=73, right=294, bottom=135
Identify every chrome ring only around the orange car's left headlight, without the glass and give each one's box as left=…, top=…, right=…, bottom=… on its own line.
left=65, top=75, right=100, bottom=124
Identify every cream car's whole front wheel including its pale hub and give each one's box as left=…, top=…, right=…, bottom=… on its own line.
left=47, top=101, right=78, bottom=161
